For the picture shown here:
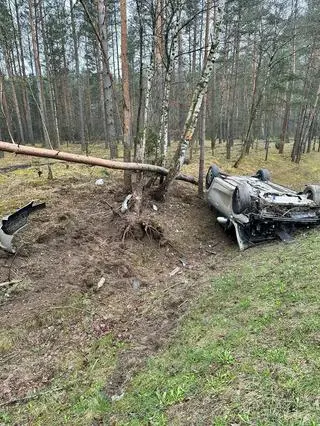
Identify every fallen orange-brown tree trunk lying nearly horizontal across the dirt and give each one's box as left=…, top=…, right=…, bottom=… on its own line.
left=0, top=141, right=198, bottom=185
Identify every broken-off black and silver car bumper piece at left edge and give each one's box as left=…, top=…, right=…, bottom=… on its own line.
left=0, top=201, right=46, bottom=253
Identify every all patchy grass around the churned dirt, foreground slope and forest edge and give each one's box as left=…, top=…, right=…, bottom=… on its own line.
left=0, top=140, right=320, bottom=426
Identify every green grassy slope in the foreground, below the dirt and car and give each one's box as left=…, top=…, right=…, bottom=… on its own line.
left=2, top=230, right=320, bottom=426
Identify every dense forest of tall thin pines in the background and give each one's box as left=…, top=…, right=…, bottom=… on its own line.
left=0, top=0, right=320, bottom=165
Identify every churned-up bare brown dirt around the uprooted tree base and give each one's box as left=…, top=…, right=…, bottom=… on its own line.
left=0, top=179, right=238, bottom=405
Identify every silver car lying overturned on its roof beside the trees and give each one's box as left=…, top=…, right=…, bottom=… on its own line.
left=206, top=165, right=320, bottom=250
